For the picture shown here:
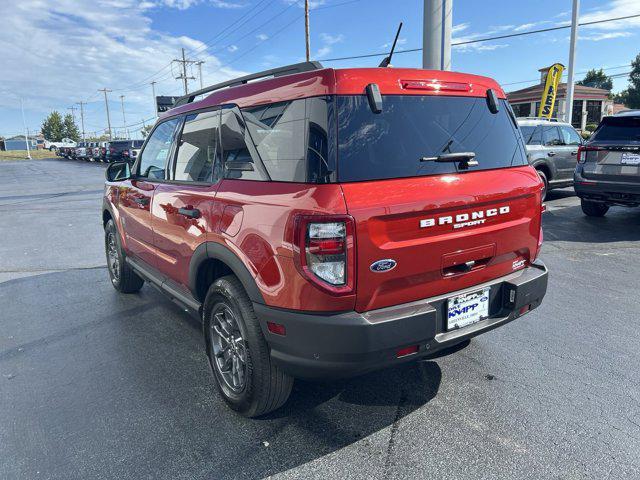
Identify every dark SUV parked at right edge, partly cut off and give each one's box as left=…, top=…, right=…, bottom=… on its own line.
left=574, top=110, right=640, bottom=217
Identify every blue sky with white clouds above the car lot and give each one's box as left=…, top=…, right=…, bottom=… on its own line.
left=0, top=0, right=640, bottom=136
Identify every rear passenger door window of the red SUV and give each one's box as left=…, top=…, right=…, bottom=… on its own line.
left=173, top=110, right=221, bottom=182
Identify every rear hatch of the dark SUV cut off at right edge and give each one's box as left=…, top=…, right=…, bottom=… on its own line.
left=580, top=115, right=640, bottom=183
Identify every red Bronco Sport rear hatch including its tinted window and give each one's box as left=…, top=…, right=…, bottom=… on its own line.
left=337, top=95, right=541, bottom=311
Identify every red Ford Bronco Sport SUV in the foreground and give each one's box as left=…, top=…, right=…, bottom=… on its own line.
left=103, top=62, right=547, bottom=416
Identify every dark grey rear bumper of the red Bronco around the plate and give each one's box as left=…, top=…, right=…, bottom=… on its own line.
left=254, top=261, right=548, bottom=378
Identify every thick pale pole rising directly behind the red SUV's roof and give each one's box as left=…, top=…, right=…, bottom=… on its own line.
left=422, top=0, right=453, bottom=70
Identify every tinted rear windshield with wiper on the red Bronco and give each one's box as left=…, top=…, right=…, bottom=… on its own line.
left=337, top=95, right=527, bottom=182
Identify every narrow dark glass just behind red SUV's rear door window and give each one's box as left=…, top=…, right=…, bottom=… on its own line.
left=220, top=107, right=267, bottom=180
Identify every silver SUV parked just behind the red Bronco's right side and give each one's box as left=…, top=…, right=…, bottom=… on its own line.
left=518, top=118, right=583, bottom=200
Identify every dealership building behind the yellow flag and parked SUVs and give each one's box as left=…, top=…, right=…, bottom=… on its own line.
left=507, top=68, right=614, bottom=130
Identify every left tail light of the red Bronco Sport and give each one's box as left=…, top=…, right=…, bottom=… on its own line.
left=295, top=215, right=355, bottom=295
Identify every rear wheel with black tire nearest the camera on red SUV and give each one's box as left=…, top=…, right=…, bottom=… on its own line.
left=202, top=275, right=293, bottom=417
